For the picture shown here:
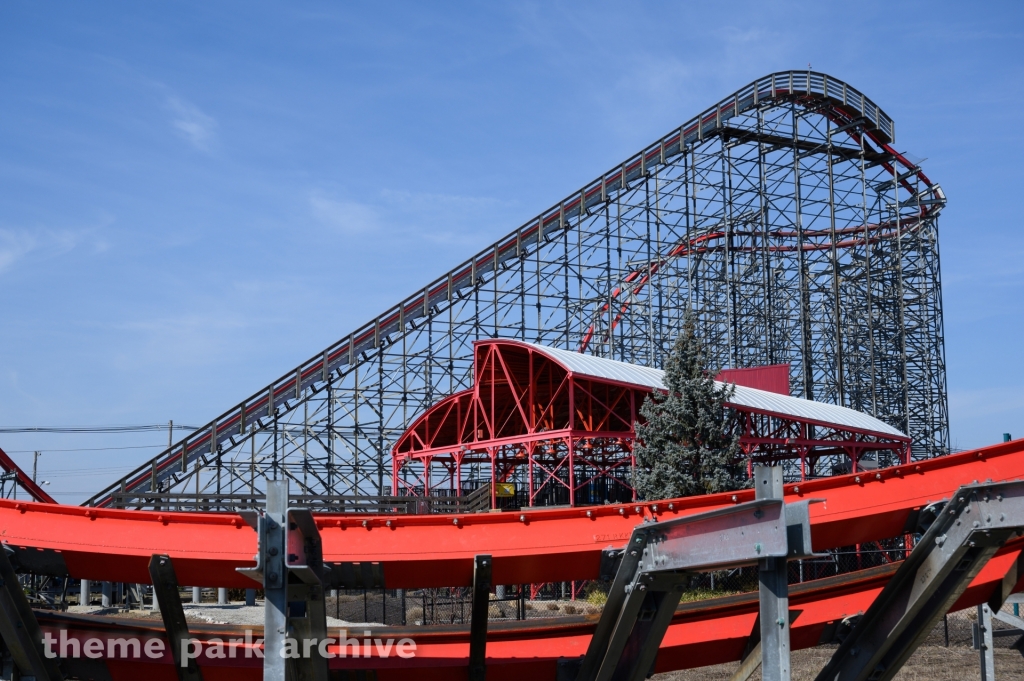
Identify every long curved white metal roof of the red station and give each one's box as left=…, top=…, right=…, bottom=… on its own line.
left=515, top=341, right=906, bottom=437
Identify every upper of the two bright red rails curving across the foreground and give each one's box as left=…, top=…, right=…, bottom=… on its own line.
left=0, top=440, right=1024, bottom=588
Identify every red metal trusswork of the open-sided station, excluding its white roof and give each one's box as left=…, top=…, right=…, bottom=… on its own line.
left=392, top=339, right=909, bottom=507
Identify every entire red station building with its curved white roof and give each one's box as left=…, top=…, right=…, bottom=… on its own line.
left=392, top=339, right=910, bottom=508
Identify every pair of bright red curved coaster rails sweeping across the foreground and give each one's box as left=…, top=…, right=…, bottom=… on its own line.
left=6, top=440, right=1024, bottom=680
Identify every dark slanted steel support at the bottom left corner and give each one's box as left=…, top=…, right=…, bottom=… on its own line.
left=0, top=546, right=63, bottom=681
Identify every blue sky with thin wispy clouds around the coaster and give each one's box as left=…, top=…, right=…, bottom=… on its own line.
left=0, top=1, right=1024, bottom=502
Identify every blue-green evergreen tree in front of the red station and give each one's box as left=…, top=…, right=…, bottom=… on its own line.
left=633, top=313, right=750, bottom=500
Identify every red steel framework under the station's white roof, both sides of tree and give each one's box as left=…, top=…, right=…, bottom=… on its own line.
left=391, top=339, right=910, bottom=499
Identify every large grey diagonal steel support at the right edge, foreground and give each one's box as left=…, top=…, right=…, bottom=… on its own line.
left=817, top=481, right=1024, bottom=681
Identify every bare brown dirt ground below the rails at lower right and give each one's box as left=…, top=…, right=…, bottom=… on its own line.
left=652, top=645, right=1024, bottom=681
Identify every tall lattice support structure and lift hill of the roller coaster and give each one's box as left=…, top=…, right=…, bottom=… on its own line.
left=87, top=72, right=948, bottom=506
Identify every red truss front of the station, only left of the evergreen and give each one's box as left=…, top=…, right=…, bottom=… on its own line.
left=393, top=340, right=649, bottom=505
